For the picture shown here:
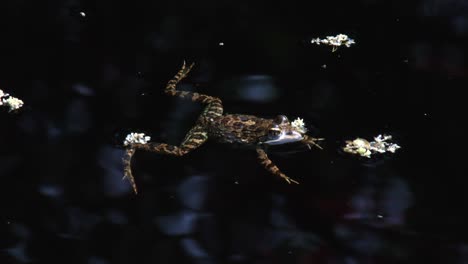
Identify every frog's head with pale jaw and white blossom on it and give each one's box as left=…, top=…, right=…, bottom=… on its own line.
left=262, top=115, right=307, bottom=145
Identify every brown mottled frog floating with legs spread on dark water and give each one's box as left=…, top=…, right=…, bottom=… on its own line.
left=123, top=61, right=323, bottom=194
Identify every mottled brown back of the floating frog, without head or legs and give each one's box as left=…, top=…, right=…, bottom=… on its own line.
left=207, top=114, right=272, bottom=146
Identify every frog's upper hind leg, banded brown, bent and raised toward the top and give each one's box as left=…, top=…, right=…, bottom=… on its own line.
left=164, top=61, right=223, bottom=119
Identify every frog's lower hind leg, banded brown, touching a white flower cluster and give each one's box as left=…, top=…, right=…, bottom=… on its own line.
left=123, top=125, right=208, bottom=194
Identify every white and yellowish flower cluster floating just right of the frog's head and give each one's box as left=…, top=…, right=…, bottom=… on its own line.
left=343, top=135, right=401, bottom=158
